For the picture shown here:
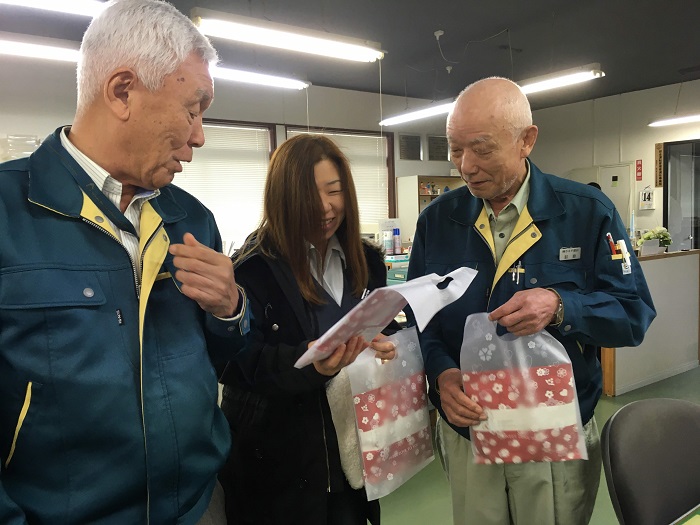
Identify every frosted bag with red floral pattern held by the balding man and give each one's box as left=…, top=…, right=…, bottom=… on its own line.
left=460, top=313, right=588, bottom=464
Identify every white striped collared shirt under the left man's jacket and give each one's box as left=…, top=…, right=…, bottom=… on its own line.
left=61, top=127, right=160, bottom=280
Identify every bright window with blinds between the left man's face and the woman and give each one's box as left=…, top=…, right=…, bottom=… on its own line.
left=174, top=123, right=272, bottom=253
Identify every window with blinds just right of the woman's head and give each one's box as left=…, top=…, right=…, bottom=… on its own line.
left=287, top=128, right=393, bottom=223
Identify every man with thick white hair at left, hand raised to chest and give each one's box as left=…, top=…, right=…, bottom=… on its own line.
left=0, top=0, right=249, bottom=525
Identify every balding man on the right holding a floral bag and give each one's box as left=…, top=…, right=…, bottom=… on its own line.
left=408, top=78, right=656, bottom=525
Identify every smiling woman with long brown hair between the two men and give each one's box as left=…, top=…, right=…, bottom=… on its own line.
left=221, top=134, right=397, bottom=525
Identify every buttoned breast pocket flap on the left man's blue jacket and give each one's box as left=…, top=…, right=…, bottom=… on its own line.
left=0, top=268, right=107, bottom=310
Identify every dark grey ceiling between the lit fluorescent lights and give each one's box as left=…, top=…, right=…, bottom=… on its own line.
left=0, top=0, right=700, bottom=109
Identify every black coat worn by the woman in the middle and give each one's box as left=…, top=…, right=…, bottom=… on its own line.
left=221, top=239, right=386, bottom=525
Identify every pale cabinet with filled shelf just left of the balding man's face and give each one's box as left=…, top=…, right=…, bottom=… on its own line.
left=396, top=175, right=464, bottom=242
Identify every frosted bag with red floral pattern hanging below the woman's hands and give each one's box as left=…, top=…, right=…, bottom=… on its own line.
left=347, top=327, right=433, bottom=501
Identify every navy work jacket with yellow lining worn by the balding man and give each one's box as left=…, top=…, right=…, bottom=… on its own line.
left=408, top=163, right=656, bottom=437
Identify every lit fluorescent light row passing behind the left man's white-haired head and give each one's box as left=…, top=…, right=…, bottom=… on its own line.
left=0, top=33, right=310, bottom=89
